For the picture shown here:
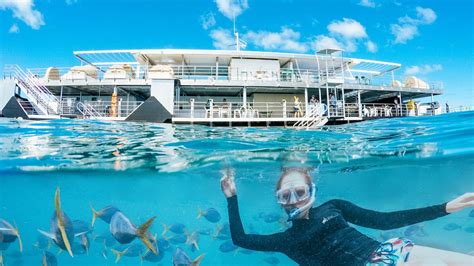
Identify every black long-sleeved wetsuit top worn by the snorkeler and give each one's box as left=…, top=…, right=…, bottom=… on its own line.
left=227, top=196, right=448, bottom=265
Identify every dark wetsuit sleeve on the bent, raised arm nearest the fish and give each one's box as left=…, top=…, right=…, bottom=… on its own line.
left=227, top=196, right=286, bottom=251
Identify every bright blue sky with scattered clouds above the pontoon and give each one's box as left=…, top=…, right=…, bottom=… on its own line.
left=0, top=0, right=474, bottom=105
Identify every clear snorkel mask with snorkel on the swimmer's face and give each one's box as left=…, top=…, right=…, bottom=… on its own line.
left=276, top=183, right=316, bottom=221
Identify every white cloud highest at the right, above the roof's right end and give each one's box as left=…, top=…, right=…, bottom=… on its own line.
left=391, top=7, right=437, bottom=44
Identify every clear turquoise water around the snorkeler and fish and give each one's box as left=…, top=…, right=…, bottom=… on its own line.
left=0, top=112, right=474, bottom=265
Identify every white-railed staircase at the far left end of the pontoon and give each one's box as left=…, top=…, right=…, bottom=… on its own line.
left=5, top=65, right=59, bottom=115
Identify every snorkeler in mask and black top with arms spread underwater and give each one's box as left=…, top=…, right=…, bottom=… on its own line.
left=221, top=168, right=474, bottom=265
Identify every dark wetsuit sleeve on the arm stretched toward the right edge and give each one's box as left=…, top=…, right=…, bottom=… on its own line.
left=330, top=200, right=449, bottom=230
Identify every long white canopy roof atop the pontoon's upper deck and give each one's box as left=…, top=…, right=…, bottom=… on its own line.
left=74, top=49, right=400, bottom=75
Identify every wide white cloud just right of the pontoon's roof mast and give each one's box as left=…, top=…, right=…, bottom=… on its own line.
left=243, top=26, right=309, bottom=53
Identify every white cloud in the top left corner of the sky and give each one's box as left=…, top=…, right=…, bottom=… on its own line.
left=0, top=0, right=44, bottom=30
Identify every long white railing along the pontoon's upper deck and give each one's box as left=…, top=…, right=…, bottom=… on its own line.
left=22, top=65, right=444, bottom=90
